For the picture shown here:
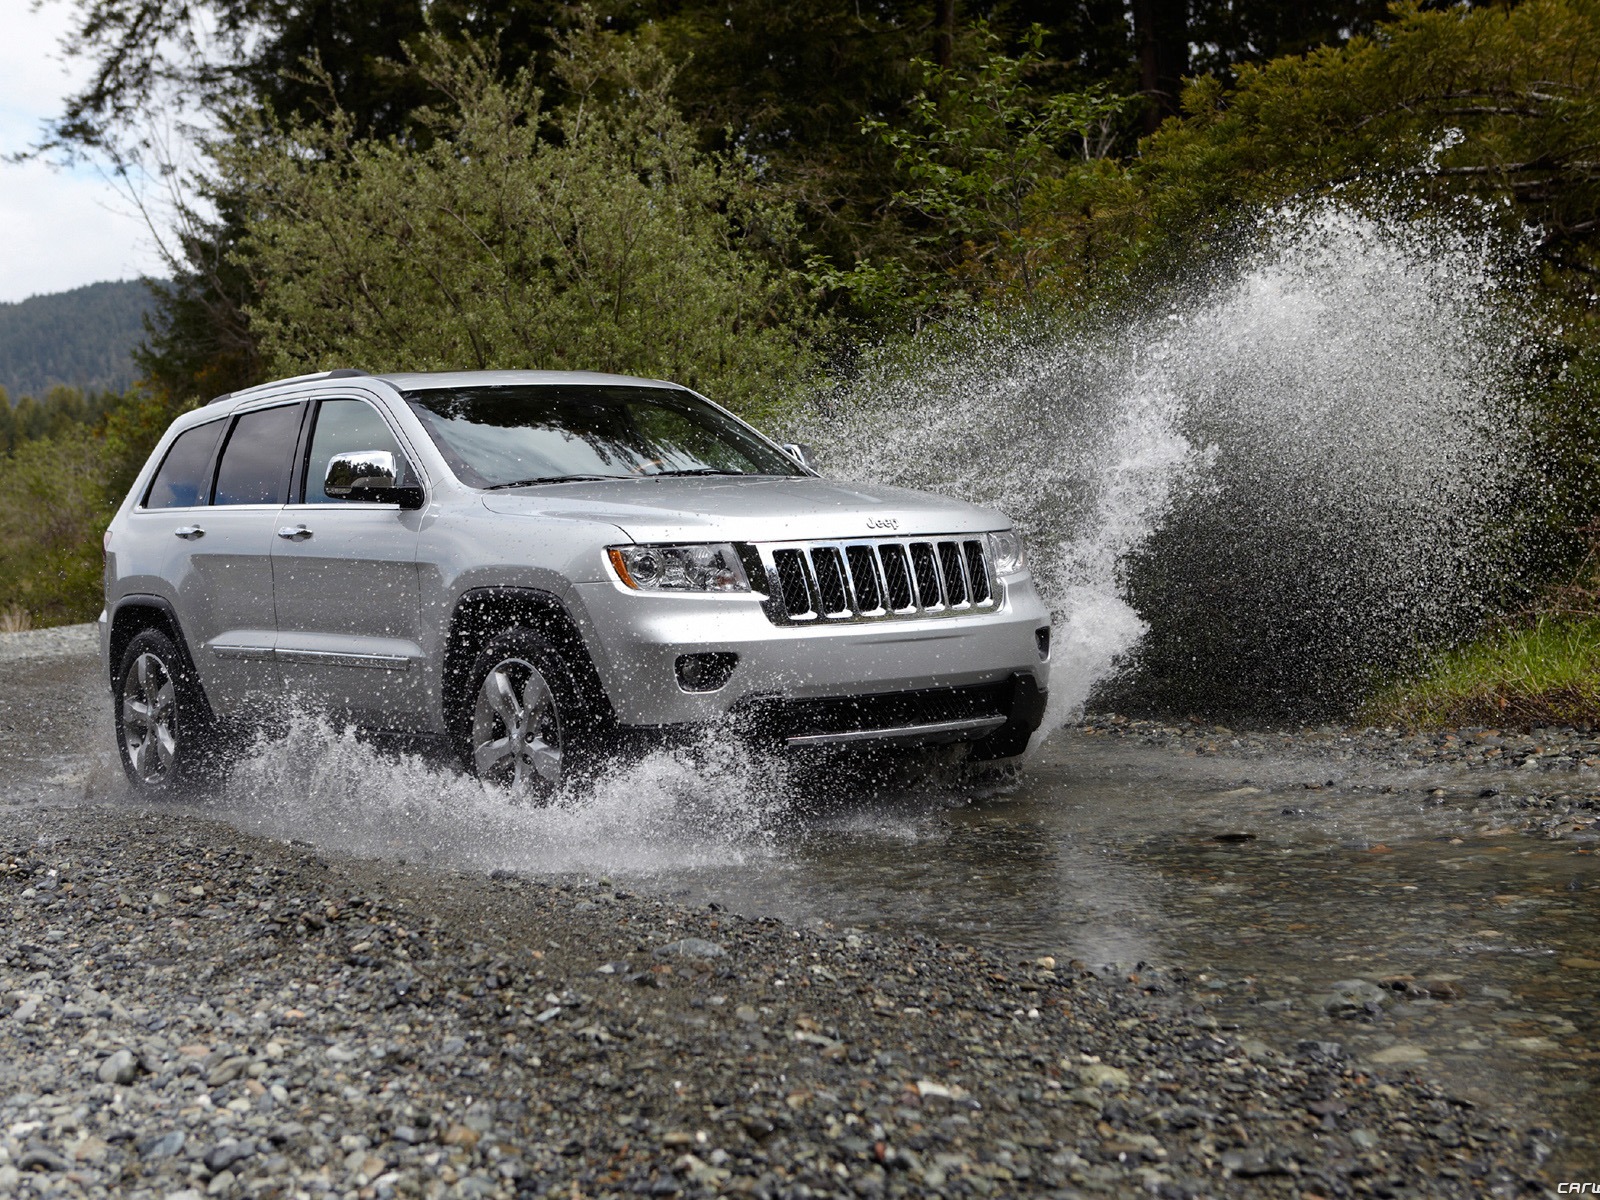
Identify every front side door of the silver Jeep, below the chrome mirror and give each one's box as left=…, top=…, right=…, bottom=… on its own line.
left=272, top=398, right=426, bottom=730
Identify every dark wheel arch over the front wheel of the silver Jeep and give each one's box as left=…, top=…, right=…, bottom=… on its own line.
left=443, top=587, right=616, bottom=748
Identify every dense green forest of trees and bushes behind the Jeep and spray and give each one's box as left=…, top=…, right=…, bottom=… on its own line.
left=0, top=0, right=1600, bottom=723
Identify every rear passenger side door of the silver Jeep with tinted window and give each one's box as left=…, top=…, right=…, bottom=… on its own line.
left=178, top=402, right=306, bottom=714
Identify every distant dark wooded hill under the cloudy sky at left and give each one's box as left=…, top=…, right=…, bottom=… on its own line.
left=0, top=280, right=150, bottom=403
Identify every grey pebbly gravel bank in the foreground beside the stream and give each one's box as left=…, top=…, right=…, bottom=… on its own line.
left=0, top=806, right=1550, bottom=1200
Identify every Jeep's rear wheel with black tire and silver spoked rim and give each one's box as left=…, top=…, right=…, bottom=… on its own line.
left=115, top=629, right=213, bottom=797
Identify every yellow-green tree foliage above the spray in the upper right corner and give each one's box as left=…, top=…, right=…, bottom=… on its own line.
left=1138, top=0, right=1600, bottom=294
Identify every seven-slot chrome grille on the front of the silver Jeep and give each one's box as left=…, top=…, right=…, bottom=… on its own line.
left=752, top=534, right=998, bottom=626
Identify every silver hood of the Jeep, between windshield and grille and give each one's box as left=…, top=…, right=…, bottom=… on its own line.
left=483, top=475, right=1011, bottom=542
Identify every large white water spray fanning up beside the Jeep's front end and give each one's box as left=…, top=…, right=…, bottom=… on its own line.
left=806, top=203, right=1526, bottom=720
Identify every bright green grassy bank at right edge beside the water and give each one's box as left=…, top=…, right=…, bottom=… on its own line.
left=1360, top=614, right=1600, bottom=728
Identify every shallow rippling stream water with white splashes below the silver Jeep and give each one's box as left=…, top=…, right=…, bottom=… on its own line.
left=0, top=658, right=1600, bottom=1179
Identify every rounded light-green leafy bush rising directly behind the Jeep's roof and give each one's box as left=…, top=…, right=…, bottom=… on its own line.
left=218, top=21, right=811, bottom=422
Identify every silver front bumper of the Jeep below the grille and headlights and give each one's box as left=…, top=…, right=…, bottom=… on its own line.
left=578, top=574, right=1050, bottom=736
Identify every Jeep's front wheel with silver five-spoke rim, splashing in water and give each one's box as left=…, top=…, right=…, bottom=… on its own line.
left=462, top=629, right=592, bottom=803
